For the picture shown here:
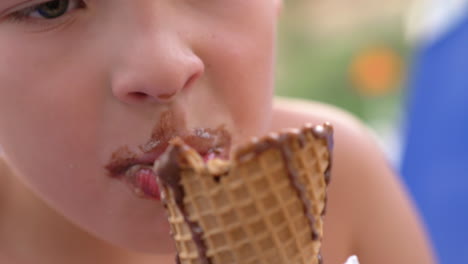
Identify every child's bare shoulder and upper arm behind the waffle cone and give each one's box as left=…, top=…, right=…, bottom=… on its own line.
left=271, top=98, right=433, bottom=264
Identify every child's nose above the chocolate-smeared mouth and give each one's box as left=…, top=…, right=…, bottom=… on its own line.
left=111, top=33, right=205, bottom=104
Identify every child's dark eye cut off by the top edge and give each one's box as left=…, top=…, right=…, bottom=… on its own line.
left=11, top=0, right=85, bottom=21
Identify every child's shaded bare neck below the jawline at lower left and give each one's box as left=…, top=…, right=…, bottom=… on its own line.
left=0, top=160, right=174, bottom=264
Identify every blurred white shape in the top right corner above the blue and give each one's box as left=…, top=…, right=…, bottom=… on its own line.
left=407, top=0, right=468, bottom=42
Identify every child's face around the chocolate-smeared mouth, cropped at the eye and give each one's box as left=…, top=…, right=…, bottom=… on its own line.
left=0, top=0, right=278, bottom=252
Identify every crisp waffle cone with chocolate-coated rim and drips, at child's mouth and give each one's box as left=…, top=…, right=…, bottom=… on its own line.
left=154, top=124, right=333, bottom=264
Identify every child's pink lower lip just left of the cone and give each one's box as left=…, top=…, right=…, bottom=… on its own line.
left=126, top=165, right=161, bottom=201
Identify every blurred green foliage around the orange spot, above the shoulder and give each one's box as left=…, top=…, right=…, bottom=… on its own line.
left=276, top=0, right=410, bottom=124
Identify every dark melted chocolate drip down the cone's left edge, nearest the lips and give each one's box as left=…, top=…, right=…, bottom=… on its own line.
left=157, top=143, right=212, bottom=264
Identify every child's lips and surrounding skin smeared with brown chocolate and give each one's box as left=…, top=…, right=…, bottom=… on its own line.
left=105, top=111, right=231, bottom=201
